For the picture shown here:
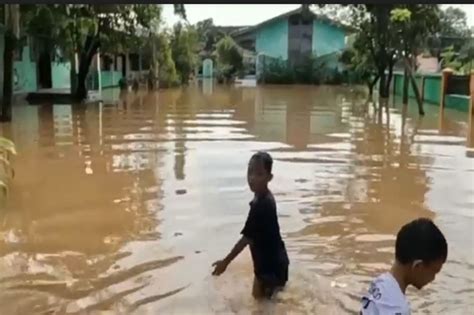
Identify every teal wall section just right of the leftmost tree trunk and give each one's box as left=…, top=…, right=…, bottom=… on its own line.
left=13, top=46, right=38, bottom=93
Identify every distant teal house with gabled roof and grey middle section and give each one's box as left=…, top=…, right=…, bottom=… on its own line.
left=231, top=8, right=351, bottom=64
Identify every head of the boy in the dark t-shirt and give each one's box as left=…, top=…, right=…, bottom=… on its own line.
left=247, top=151, right=273, bottom=193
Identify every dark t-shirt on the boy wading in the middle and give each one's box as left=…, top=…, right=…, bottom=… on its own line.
left=241, top=192, right=289, bottom=282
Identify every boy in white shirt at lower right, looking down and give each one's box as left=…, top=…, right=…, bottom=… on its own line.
left=360, top=218, right=448, bottom=315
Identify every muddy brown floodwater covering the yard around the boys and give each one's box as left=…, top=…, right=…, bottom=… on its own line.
left=0, top=83, right=474, bottom=315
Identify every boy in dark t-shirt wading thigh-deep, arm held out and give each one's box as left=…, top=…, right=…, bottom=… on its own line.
left=212, top=152, right=289, bottom=298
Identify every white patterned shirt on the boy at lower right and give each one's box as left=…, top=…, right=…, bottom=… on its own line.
left=360, top=272, right=411, bottom=315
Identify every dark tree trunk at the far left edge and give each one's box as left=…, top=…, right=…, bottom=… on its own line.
left=0, top=29, right=16, bottom=122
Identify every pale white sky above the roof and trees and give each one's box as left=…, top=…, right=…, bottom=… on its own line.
left=163, top=4, right=474, bottom=26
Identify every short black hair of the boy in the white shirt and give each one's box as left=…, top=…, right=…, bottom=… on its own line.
left=395, top=218, right=448, bottom=265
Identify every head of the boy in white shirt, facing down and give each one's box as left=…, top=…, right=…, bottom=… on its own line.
left=395, top=218, right=448, bottom=289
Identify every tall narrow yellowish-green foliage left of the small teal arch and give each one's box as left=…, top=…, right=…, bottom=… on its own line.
left=171, top=23, right=198, bottom=84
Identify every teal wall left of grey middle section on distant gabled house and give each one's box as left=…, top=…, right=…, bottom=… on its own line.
left=255, top=19, right=288, bottom=60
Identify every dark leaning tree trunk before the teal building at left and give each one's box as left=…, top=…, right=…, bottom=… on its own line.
left=74, top=35, right=100, bottom=101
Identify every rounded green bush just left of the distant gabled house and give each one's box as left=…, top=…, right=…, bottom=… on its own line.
left=216, top=36, right=244, bottom=80
